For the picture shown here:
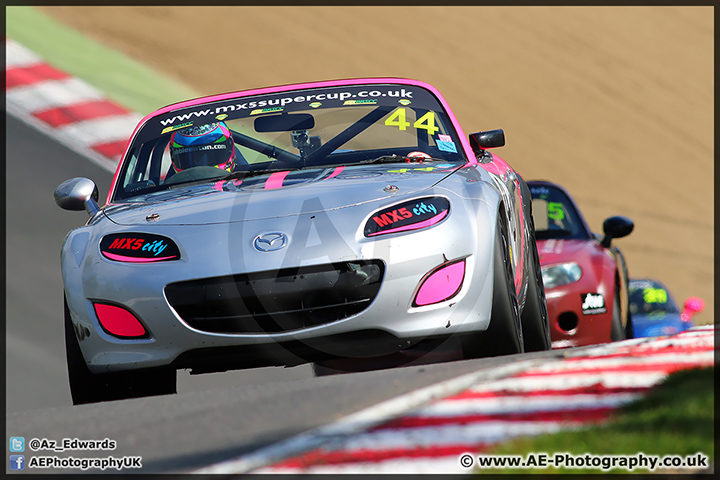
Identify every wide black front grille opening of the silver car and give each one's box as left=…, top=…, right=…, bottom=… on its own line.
left=165, top=260, right=384, bottom=333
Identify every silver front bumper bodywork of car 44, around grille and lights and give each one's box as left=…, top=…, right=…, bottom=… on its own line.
left=62, top=193, right=495, bottom=373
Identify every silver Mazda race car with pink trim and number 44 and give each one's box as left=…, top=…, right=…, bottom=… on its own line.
left=55, top=78, right=550, bottom=404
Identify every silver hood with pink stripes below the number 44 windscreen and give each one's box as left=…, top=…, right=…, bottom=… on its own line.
left=103, top=163, right=462, bottom=226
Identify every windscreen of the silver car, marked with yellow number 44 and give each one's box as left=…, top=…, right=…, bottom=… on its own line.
left=113, top=84, right=467, bottom=201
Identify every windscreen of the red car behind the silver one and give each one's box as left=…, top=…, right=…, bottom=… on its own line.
left=530, top=185, right=590, bottom=240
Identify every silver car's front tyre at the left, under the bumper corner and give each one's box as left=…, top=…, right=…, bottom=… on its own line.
left=65, top=301, right=177, bottom=405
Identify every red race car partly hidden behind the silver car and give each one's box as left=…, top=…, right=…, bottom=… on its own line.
left=527, top=181, right=634, bottom=348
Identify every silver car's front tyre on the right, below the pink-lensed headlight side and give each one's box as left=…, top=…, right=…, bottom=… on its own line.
left=462, top=216, right=525, bottom=358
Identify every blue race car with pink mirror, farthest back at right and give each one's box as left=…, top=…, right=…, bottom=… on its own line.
left=630, top=278, right=705, bottom=338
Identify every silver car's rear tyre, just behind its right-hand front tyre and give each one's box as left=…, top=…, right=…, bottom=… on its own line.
left=522, top=235, right=552, bottom=352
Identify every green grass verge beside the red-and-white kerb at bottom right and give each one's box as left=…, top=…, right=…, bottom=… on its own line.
left=481, top=367, right=715, bottom=474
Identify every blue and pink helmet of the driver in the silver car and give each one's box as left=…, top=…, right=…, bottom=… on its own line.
left=170, top=122, right=235, bottom=172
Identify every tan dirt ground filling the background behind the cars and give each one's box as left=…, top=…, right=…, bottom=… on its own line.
left=41, top=6, right=714, bottom=323
